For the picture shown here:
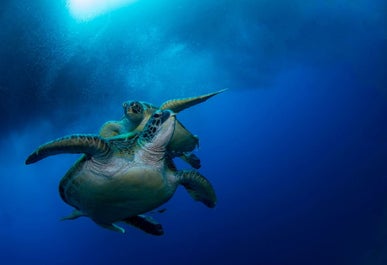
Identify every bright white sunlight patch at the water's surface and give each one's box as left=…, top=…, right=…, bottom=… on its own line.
left=67, top=0, right=137, bottom=21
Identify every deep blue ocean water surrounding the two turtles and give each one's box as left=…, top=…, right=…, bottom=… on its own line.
left=0, top=0, right=387, bottom=265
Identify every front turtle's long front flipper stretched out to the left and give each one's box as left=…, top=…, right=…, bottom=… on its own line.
left=25, top=134, right=111, bottom=165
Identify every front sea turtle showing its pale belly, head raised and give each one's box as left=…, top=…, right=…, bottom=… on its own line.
left=26, top=110, right=216, bottom=235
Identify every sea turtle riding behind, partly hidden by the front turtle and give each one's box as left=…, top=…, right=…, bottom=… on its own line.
left=99, top=89, right=225, bottom=169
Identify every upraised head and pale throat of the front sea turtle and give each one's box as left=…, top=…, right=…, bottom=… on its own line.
left=139, top=110, right=176, bottom=150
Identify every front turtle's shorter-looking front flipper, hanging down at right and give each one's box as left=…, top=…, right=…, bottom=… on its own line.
left=175, top=170, right=216, bottom=208
